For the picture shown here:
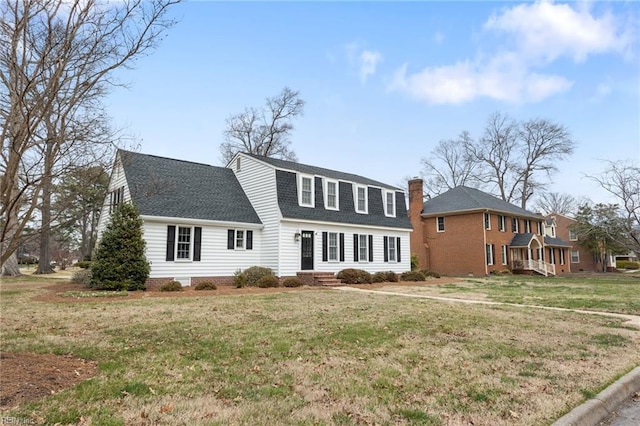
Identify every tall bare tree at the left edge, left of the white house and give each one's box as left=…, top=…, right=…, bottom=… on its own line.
left=0, top=0, right=177, bottom=274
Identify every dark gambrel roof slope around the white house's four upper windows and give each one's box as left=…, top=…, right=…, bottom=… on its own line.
left=276, top=170, right=412, bottom=229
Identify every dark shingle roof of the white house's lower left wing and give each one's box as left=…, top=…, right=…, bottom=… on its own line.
left=118, top=150, right=261, bottom=224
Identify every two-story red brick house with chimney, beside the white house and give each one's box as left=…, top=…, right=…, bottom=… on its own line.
left=409, top=179, right=570, bottom=275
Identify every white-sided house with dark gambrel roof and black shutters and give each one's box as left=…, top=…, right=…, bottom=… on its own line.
left=99, top=150, right=411, bottom=286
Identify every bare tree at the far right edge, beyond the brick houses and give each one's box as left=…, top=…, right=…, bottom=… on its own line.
left=589, top=160, right=640, bottom=254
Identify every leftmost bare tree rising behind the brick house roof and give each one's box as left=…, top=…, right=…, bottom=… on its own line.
left=420, top=131, right=480, bottom=196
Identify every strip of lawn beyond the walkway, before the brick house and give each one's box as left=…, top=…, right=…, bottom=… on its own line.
left=376, top=273, right=640, bottom=315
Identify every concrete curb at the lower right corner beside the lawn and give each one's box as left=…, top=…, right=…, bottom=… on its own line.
left=552, top=367, right=640, bottom=426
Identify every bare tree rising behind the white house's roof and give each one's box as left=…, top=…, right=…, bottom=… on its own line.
left=220, top=87, right=304, bottom=164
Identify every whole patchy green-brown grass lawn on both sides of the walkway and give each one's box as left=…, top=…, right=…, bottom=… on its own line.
left=0, top=277, right=640, bottom=425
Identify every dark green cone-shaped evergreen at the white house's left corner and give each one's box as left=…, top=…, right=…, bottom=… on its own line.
left=90, top=203, right=151, bottom=290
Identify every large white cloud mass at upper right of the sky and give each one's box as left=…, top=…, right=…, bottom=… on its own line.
left=389, top=1, right=634, bottom=104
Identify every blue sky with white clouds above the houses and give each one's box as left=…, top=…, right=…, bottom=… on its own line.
left=107, top=1, right=640, bottom=206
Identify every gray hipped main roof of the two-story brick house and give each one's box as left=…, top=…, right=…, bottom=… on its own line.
left=423, top=186, right=541, bottom=219
